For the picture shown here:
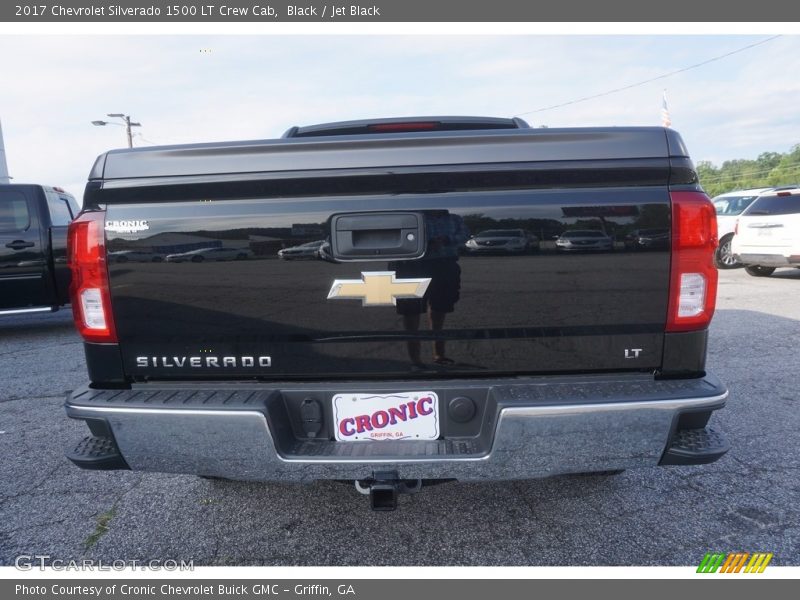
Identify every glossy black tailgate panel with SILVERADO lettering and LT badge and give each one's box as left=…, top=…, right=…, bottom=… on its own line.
left=106, top=185, right=670, bottom=379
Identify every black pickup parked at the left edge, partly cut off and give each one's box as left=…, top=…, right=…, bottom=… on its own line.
left=0, top=184, right=78, bottom=316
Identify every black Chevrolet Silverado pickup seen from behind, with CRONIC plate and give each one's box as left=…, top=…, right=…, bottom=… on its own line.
left=66, top=117, right=728, bottom=509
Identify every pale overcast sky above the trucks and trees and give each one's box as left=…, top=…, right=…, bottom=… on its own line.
left=0, top=35, right=800, bottom=197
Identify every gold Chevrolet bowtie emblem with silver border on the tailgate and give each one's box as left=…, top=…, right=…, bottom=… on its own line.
left=328, top=271, right=431, bottom=306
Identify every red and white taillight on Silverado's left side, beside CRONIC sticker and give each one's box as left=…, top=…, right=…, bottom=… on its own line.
left=67, top=211, right=117, bottom=343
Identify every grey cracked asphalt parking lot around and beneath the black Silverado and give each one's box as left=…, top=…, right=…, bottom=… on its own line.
left=0, top=270, right=800, bottom=565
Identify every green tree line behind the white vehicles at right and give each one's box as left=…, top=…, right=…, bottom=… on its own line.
left=697, top=144, right=800, bottom=198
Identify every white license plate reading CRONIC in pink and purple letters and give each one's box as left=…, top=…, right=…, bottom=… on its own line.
left=333, top=392, right=439, bottom=442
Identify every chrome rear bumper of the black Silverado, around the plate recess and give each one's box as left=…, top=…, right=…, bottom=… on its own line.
left=66, top=375, right=728, bottom=482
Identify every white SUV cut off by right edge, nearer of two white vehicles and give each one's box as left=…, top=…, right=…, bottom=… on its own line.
left=731, top=188, right=800, bottom=277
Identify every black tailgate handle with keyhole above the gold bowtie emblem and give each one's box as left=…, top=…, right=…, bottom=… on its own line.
left=331, top=212, right=425, bottom=260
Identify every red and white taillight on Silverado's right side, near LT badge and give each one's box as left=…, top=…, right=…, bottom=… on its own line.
left=667, top=192, right=717, bottom=332
